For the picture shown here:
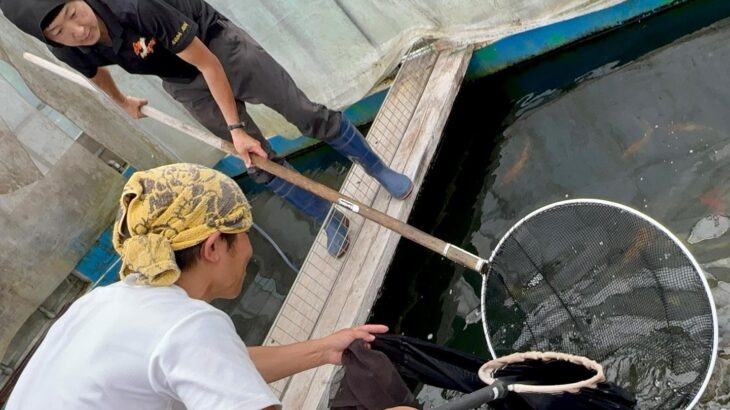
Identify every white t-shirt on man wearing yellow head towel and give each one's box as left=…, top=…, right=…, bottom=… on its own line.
left=6, top=281, right=279, bottom=410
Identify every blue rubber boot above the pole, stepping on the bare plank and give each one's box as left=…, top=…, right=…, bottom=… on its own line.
left=327, top=115, right=413, bottom=199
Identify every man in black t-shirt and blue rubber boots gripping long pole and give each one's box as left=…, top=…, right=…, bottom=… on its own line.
left=0, top=0, right=413, bottom=257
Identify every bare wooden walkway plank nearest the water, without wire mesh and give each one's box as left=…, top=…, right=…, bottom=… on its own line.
left=274, top=50, right=471, bottom=409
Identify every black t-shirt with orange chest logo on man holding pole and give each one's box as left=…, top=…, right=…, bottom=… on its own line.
left=49, top=0, right=224, bottom=82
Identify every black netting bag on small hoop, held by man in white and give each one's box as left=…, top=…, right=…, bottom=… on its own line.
left=329, top=334, right=635, bottom=410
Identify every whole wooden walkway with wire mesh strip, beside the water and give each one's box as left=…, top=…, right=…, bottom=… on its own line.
left=265, top=48, right=471, bottom=409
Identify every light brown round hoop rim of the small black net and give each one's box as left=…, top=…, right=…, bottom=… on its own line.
left=479, top=352, right=606, bottom=394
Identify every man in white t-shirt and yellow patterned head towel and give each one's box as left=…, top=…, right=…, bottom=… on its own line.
left=6, top=164, right=387, bottom=410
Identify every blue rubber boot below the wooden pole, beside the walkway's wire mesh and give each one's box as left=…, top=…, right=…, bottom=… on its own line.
left=266, top=172, right=350, bottom=258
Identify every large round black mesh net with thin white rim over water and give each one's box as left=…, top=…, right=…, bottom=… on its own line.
left=482, top=202, right=715, bottom=409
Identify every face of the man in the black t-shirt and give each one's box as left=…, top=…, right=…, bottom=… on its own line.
left=43, top=0, right=101, bottom=47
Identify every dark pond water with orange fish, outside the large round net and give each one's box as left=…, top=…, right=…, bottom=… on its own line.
left=371, top=0, right=730, bottom=409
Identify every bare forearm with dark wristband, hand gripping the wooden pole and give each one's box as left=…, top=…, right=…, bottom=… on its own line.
left=177, top=37, right=266, bottom=166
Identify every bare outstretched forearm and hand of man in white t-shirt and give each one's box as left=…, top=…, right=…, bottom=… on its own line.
left=248, top=325, right=388, bottom=383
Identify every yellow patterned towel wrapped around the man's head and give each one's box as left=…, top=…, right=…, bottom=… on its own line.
left=112, top=164, right=252, bottom=286
